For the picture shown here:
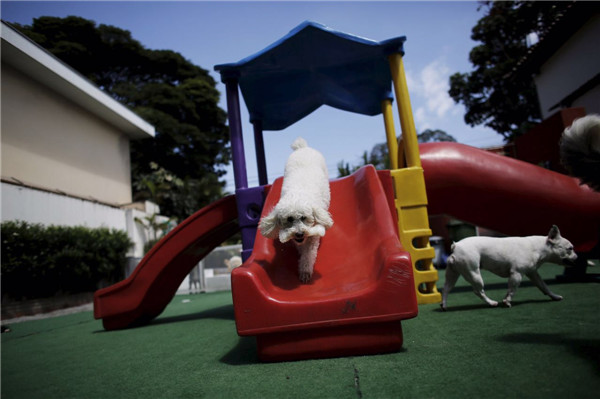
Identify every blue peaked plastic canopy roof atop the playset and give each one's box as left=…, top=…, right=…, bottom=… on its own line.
left=215, top=21, right=406, bottom=130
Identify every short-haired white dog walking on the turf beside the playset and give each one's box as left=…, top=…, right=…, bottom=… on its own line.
left=442, top=226, right=577, bottom=310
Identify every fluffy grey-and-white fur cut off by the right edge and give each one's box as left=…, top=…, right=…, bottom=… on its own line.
left=560, top=115, right=600, bottom=192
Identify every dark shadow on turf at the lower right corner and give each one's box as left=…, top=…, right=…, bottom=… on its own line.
left=497, top=333, right=600, bottom=374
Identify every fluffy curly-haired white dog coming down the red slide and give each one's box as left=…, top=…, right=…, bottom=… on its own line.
left=258, top=137, right=333, bottom=283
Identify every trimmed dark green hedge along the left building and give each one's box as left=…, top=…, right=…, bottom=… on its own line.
left=2, top=222, right=132, bottom=299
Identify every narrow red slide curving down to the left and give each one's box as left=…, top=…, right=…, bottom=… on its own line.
left=94, top=195, right=239, bottom=330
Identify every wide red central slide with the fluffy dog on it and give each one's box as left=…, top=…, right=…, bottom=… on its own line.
left=232, top=166, right=418, bottom=361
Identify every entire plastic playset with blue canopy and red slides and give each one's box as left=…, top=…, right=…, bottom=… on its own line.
left=94, top=22, right=600, bottom=360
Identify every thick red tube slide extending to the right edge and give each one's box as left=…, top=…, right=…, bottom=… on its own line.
left=420, top=143, right=600, bottom=252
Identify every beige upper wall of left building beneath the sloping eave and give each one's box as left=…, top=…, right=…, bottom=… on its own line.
left=1, top=62, right=131, bottom=204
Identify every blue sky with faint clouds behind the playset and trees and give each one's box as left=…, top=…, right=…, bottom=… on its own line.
left=1, top=1, right=503, bottom=191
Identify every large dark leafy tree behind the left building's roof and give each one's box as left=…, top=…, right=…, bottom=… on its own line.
left=15, top=17, right=230, bottom=220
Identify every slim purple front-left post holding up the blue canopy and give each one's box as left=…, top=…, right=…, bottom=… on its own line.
left=224, top=78, right=248, bottom=189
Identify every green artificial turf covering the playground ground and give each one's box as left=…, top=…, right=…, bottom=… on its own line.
left=1, top=265, right=600, bottom=399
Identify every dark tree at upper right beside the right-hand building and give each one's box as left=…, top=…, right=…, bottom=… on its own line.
left=449, top=1, right=570, bottom=140
